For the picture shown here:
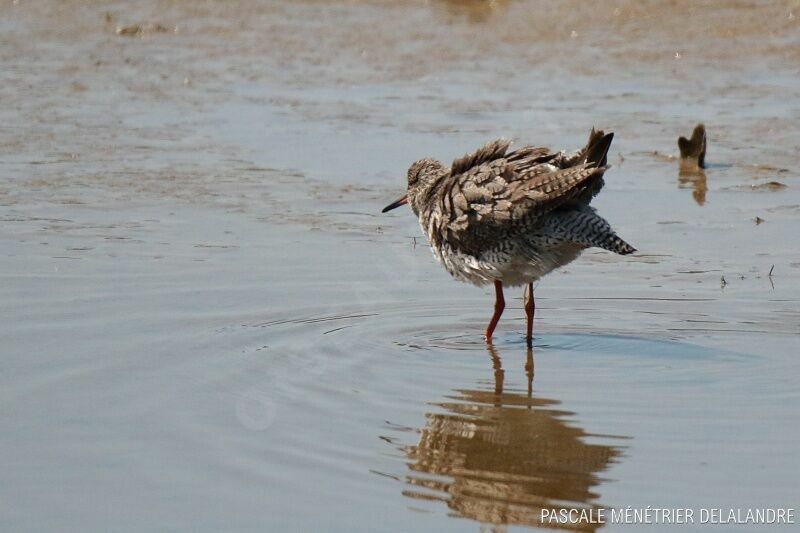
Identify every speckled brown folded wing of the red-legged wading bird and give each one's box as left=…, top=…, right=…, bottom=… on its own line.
left=440, top=141, right=605, bottom=255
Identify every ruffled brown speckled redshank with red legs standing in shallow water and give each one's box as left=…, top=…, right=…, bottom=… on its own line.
left=383, top=129, right=636, bottom=344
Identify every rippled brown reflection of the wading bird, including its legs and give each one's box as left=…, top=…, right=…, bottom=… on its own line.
left=403, top=347, right=621, bottom=531
